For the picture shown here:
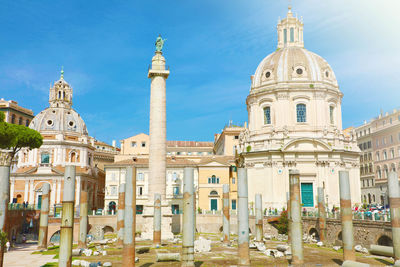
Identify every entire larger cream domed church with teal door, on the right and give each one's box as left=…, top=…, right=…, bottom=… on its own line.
left=239, top=8, right=361, bottom=209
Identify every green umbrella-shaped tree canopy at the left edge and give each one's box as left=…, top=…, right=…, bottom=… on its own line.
left=0, top=112, right=43, bottom=160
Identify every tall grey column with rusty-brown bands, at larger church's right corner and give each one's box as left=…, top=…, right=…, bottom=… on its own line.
left=339, top=171, right=356, bottom=261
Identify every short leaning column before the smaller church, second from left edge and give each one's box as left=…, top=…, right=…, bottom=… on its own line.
left=38, top=183, right=50, bottom=249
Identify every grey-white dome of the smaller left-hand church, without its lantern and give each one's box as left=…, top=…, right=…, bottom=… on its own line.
left=29, top=107, right=88, bottom=135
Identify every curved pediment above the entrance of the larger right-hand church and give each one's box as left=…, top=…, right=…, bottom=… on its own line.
left=282, top=138, right=332, bottom=152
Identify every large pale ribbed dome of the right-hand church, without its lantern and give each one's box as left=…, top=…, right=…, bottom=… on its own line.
left=252, top=46, right=338, bottom=88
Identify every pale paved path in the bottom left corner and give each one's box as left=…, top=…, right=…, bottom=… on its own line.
left=4, top=242, right=57, bottom=267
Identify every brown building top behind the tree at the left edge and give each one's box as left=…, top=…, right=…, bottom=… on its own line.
left=0, top=98, right=34, bottom=126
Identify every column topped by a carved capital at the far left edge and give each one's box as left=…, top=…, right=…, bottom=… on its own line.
left=0, top=151, right=12, bottom=267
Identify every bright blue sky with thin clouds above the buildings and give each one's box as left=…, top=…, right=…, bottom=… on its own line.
left=0, top=0, right=400, bottom=147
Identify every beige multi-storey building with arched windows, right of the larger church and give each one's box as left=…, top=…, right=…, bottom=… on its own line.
left=356, top=109, right=400, bottom=205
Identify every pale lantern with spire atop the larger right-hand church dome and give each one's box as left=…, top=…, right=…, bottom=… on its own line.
left=277, top=6, right=304, bottom=49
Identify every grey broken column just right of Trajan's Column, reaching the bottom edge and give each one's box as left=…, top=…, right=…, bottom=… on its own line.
left=182, top=167, right=195, bottom=266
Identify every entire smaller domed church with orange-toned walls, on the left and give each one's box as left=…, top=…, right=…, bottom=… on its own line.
left=10, top=72, right=105, bottom=213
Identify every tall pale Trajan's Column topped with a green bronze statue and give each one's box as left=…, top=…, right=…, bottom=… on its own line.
left=142, top=36, right=173, bottom=239
